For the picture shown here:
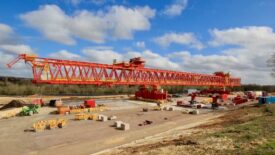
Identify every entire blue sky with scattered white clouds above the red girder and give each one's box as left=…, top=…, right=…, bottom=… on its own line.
left=0, top=0, right=275, bottom=84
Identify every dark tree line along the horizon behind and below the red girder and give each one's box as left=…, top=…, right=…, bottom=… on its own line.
left=0, top=77, right=275, bottom=96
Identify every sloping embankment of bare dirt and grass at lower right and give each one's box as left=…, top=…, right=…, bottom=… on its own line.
left=100, top=102, right=275, bottom=155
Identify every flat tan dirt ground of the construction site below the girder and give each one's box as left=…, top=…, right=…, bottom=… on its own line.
left=0, top=97, right=258, bottom=155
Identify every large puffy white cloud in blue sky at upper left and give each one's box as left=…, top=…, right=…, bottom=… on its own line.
left=20, top=5, right=155, bottom=45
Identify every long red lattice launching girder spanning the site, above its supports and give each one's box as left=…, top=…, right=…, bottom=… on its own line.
left=8, top=54, right=241, bottom=87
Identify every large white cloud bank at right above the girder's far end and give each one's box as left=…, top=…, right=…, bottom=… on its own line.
left=166, top=27, right=275, bottom=84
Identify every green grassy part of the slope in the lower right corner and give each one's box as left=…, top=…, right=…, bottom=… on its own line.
left=209, top=104, right=275, bottom=154
